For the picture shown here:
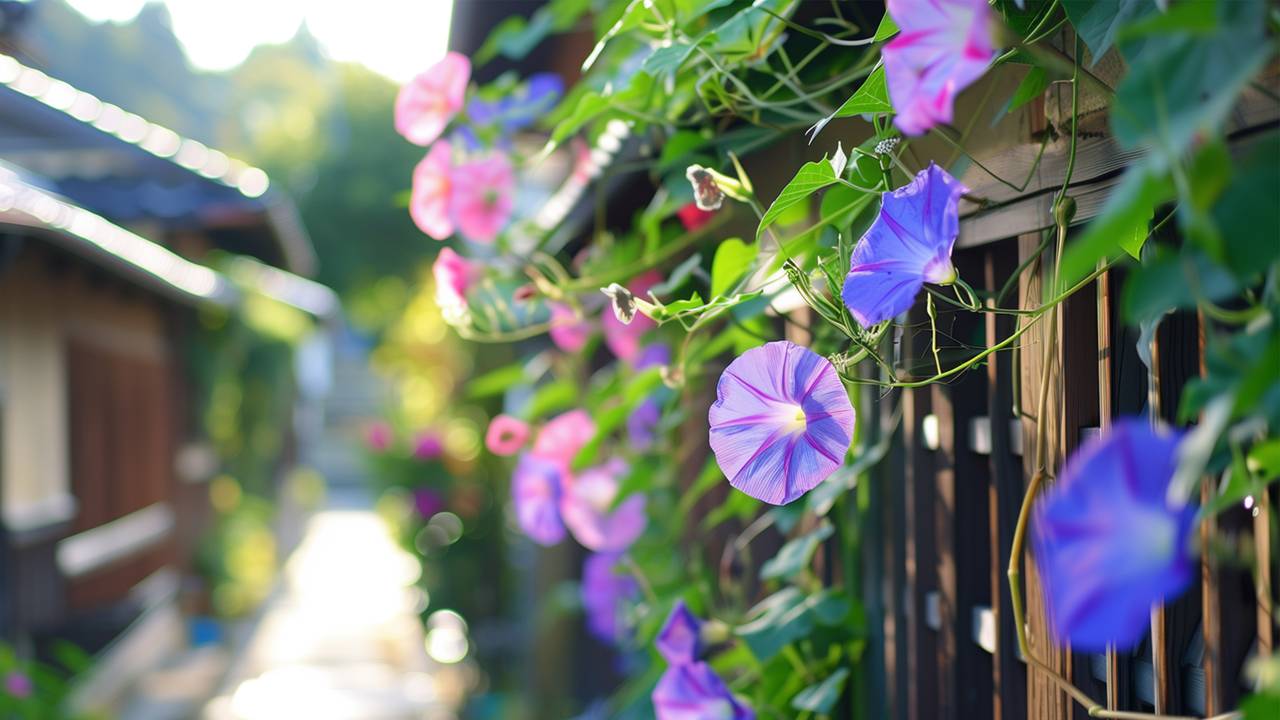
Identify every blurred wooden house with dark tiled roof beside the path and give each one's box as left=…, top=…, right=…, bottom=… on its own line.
left=0, top=50, right=337, bottom=702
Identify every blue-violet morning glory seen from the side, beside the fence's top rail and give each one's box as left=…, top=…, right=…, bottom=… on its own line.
left=841, top=163, right=969, bottom=327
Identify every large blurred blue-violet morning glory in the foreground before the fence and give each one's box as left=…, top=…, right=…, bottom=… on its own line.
left=1032, top=419, right=1196, bottom=652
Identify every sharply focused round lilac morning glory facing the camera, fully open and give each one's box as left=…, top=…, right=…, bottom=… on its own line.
left=708, top=341, right=854, bottom=505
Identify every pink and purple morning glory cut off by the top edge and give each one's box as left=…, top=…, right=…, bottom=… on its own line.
left=881, top=0, right=996, bottom=135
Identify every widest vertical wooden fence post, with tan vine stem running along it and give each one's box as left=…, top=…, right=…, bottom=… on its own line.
left=984, top=240, right=1027, bottom=720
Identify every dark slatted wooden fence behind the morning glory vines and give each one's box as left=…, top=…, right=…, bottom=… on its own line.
left=863, top=79, right=1280, bottom=720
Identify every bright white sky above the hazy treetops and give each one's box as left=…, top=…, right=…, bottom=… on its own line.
left=67, top=0, right=453, bottom=82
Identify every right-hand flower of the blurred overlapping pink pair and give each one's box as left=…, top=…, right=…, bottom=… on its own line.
left=449, top=154, right=516, bottom=245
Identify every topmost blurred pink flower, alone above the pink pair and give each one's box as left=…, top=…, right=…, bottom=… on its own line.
left=396, top=53, right=471, bottom=147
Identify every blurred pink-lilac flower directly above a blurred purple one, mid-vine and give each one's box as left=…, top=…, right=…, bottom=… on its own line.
left=561, top=460, right=648, bottom=552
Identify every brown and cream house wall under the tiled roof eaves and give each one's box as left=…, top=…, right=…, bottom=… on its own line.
left=0, top=238, right=184, bottom=634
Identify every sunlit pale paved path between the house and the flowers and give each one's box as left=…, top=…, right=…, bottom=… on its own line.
left=204, top=509, right=466, bottom=720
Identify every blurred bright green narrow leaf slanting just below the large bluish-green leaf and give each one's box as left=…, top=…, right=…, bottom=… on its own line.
left=1059, top=165, right=1174, bottom=288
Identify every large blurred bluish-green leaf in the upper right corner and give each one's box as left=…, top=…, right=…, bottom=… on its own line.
left=1100, top=3, right=1271, bottom=168
